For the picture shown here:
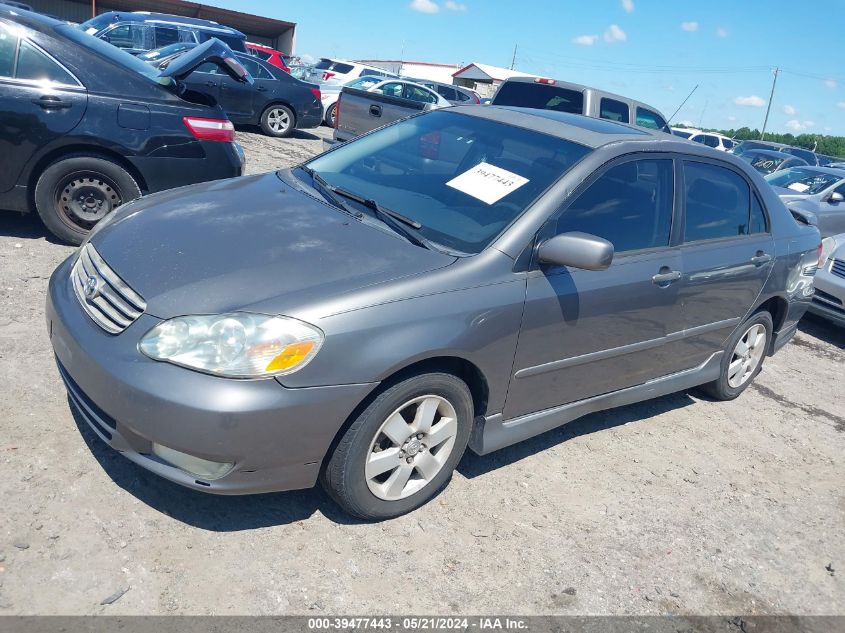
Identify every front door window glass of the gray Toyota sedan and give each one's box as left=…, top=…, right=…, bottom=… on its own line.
left=556, top=159, right=674, bottom=253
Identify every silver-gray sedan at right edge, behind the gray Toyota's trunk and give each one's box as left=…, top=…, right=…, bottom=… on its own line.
left=766, top=167, right=845, bottom=237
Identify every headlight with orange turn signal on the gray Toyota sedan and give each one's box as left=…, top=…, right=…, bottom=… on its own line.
left=138, top=312, right=324, bottom=378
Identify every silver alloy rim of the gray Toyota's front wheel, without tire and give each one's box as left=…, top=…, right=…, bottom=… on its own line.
left=364, top=395, right=458, bottom=501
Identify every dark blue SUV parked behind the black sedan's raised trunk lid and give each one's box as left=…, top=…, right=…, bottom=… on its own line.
left=79, top=11, right=247, bottom=55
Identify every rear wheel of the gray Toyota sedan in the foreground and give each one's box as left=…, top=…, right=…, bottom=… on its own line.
left=701, top=311, right=774, bottom=401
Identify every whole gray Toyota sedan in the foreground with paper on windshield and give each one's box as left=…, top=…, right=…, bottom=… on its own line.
left=46, top=106, right=819, bottom=519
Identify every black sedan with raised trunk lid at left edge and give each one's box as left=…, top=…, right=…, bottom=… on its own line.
left=0, top=5, right=252, bottom=244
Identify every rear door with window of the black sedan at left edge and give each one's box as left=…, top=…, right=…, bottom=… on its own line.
left=0, top=23, right=88, bottom=192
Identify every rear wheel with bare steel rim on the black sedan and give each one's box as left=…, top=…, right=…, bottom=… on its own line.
left=35, top=155, right=141, bottom=244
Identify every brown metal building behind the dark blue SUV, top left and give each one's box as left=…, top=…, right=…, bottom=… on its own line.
left=23, top=0, right=296, bottom=54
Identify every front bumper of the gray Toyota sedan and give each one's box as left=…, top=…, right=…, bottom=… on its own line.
left=47, top=258, right=375, bottom=494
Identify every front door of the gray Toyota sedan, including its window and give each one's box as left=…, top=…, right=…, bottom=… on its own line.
left=504, top=157, right=684, bottom=419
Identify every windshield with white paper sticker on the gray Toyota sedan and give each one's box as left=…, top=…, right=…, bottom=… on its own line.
left=306, top=110, right=590, bottom=254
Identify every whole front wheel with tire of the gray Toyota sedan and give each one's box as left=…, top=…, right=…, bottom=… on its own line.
left=322, top=373, right=473, bottom=520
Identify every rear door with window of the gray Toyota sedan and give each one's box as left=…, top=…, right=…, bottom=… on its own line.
left=679, top=158, right=774, bottom=366
